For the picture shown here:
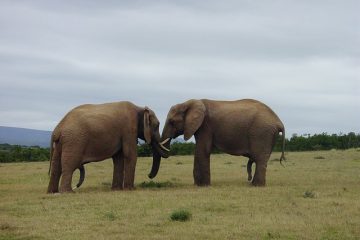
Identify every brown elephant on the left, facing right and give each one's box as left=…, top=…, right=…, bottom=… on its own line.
left=47, top=101, right=169, bottom=193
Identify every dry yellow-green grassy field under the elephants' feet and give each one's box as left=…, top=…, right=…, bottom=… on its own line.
left=0, top=149, right=360, bottom=240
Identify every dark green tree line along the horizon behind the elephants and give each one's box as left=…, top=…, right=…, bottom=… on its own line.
left=0, top=132, right=360, bottom=163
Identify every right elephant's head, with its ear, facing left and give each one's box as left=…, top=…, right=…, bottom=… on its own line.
left=149, top=100, right=206, bottom=178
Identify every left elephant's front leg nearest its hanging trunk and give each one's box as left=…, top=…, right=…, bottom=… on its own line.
left=123, top=140, right=137, bottom=190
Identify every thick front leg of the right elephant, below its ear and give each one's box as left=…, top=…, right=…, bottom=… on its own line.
left=193, top=133, right=211, bottom=186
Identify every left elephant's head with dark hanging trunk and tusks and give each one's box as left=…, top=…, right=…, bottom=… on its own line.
left=143, top=107, right=170, bottom=178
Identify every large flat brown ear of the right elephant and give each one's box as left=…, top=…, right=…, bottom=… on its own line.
left=184, top=100, right=206, bottom=141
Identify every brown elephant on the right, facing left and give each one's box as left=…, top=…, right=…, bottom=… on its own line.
left=149, top=99, right=285, bottom=186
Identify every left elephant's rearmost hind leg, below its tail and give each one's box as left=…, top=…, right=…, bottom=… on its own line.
left=47, top=144, right=61, bottom=193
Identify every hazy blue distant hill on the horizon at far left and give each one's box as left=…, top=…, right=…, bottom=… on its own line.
left=0, top=126, right=51, bottom=147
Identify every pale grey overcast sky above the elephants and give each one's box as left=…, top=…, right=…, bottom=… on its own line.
left=0, top=0, right=360, bottom=136
